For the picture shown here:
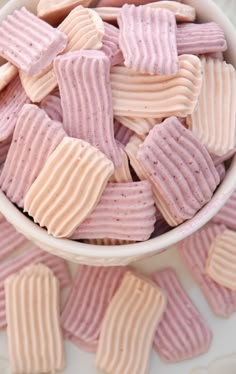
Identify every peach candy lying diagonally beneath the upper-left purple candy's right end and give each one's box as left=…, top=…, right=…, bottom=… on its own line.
left=20, top=6, right=105, bottom=102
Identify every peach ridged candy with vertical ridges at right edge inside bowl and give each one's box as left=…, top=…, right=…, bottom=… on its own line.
left=190, top=57, right=236, bottom=156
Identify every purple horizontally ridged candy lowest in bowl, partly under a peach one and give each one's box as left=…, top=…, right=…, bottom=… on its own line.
left=72, top=181, right=156, bottom=241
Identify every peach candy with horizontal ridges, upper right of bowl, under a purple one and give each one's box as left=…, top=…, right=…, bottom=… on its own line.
left=111, top=55, right=202, bottom=118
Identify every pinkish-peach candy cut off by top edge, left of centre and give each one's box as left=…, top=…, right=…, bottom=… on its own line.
left=37, top=0, right=92, bottom=26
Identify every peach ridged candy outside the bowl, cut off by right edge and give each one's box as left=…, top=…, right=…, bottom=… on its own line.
left=206, top=229, right=236, bottom=291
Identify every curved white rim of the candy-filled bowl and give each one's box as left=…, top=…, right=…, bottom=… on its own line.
left=0, top=0, right=236, bottom=259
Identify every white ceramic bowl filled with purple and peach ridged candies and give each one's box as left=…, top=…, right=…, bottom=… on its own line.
left=0, top=0, right=236, bottom=266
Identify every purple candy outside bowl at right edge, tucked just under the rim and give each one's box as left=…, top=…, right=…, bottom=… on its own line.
left=212, top=192, right=236, bottom=230
